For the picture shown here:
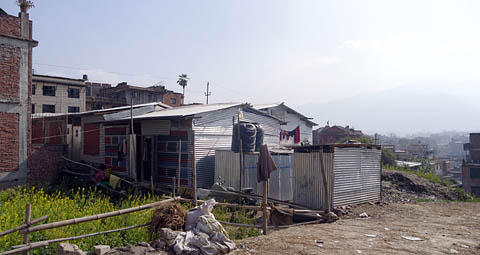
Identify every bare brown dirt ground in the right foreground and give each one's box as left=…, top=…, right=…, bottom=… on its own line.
left=232, top=202, right=480, bottom=254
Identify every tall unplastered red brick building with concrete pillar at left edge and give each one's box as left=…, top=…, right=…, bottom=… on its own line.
left=0, top=9, right=38, bottom=187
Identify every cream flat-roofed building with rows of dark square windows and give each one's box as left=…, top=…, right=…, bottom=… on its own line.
left=32, top=74, right=86, bottom=113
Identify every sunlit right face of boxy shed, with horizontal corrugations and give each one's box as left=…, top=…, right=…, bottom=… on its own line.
left=333, top=148, right=381, bottom=206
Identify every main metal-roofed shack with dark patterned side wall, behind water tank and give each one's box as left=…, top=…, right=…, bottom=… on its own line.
left=103, top=103, right=283, bottom=188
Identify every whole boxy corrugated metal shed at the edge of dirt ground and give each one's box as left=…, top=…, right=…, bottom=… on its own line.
left=293, top=144, right=381, bottom=209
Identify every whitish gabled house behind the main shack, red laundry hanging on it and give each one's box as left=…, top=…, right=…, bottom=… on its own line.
left=253, top=103, right=318, bottom=145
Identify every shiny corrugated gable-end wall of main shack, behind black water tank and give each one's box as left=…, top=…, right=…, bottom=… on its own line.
left=192, top=107, right=280, bottom=188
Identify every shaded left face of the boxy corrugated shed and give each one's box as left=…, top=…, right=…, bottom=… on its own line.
left=293, top=152, right=333, bottom=209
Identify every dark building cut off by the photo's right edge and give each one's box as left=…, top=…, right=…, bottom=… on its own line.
left=462, top=133, right=480, bottom=196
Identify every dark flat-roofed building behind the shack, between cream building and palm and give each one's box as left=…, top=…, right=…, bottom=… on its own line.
left=84, top=80, right=183, bottom=111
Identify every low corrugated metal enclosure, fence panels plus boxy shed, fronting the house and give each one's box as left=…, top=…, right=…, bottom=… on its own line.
left=215, top=144, right=381, bottom=209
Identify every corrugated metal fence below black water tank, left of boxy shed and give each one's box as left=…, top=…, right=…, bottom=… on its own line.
left=215, top=150, right=294, bottom=201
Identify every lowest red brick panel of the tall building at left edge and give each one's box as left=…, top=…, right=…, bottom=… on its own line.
left=0, top=112, right=18, bottom=172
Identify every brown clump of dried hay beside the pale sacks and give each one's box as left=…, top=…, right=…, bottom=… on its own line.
left=149, top=203, right=185, bottom=240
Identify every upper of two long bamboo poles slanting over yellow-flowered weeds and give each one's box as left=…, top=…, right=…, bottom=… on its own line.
left=20, top=198, right=175, bottom=233
